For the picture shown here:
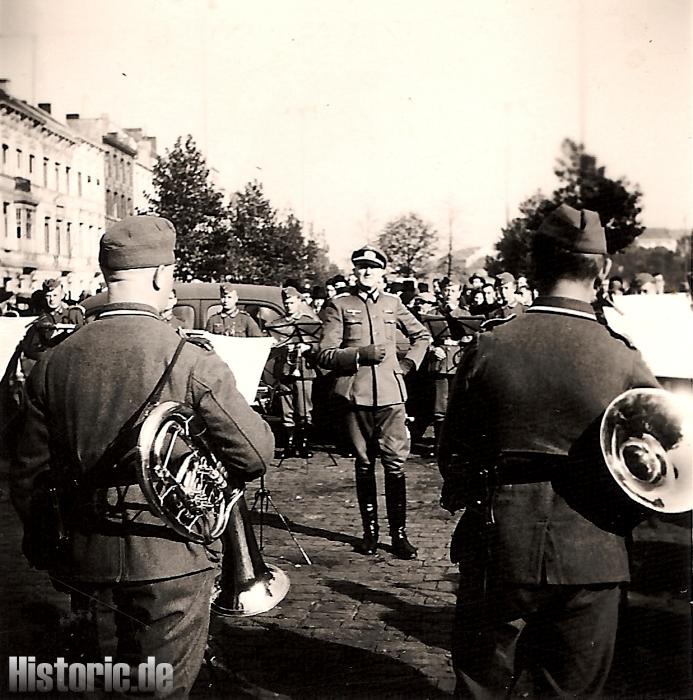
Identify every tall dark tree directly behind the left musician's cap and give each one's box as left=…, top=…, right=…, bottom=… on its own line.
left=149, top=135, right=228, bottom=280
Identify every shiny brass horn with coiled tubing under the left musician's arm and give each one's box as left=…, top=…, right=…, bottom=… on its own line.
left=137, top=401, right=289, bottom=616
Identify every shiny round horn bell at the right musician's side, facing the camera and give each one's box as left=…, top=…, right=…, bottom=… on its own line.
left=600, top=389, right=693, bottom=513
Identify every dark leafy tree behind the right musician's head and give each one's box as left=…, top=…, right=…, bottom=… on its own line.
left=486, top=139, right=644, bottom=275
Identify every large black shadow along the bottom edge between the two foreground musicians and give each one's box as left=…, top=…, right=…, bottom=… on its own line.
left=203, top=621, right=449, bottom=699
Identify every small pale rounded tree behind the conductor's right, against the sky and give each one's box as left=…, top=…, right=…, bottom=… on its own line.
left=378, top=212, right=438, bottom=276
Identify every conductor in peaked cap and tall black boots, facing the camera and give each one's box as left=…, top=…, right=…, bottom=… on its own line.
left=318, top=247, right=430, bottom=559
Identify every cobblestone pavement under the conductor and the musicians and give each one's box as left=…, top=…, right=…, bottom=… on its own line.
left=0, top=452, right=691, bottom=698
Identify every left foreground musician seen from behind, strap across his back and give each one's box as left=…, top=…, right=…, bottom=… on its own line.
left=12, top=216, right=274, bottom=697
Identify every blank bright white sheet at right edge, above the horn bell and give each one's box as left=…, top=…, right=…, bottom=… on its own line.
left=604, top=294, right=693, bottom=379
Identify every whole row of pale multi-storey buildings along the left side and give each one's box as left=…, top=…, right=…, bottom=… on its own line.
left=0, top=80, right=156, bottom=299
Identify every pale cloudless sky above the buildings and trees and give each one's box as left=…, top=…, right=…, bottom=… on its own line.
left=0, top=0, right=693, bottom=264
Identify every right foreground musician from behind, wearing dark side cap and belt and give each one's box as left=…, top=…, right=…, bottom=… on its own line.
left=439, top=204, right=658, bottom=698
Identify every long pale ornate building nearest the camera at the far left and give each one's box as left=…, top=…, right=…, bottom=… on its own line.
left=0, top=80, right=105, bottom=295
